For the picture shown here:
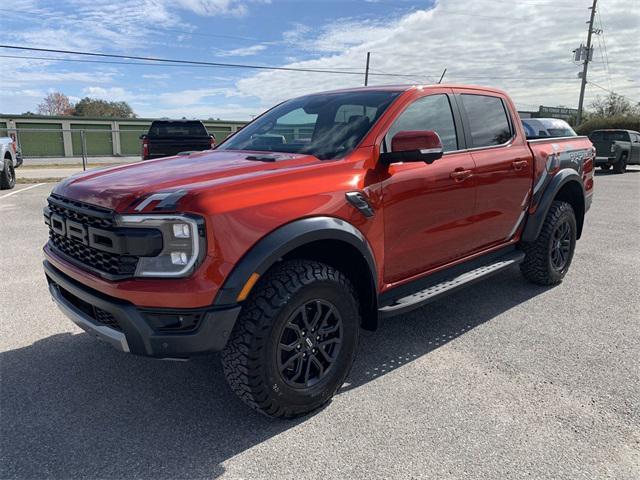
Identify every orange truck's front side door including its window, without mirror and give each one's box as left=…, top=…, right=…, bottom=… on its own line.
left=382, top=93, right=476, bottom=283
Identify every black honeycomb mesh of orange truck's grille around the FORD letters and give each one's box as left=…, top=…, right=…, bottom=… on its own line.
left=45, top=196, right=138, bottom=278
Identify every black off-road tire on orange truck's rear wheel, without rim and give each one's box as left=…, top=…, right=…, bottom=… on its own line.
left=520, top=201, right=577, bottom=285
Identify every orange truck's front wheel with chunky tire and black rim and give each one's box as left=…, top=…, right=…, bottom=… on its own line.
left=222, top=260, right=360, bottom=418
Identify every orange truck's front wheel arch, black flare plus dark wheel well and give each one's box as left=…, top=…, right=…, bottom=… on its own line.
left=214, top=217, right=378, bottom=330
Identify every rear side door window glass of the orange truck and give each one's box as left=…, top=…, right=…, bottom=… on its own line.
left=461, top=94, right=513, bottom=148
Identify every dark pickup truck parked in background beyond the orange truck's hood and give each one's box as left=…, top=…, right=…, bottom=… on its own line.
left=140, top=120, right=216, bottom=160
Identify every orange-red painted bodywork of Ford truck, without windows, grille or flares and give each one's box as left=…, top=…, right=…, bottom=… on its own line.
left=44, top=86, right=593, bottom=308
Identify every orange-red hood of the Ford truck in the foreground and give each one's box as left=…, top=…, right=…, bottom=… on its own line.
left=53, top=150, right=320, bottom=212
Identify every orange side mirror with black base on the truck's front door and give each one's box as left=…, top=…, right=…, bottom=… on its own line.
left=380, top=130, right=443, bottom=165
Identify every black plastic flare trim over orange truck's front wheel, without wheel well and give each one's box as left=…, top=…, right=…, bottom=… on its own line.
left=213, top=217, right=378, bottom=306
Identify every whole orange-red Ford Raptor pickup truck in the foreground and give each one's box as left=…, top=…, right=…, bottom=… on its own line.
left=44, top=85, right=595, bottom=417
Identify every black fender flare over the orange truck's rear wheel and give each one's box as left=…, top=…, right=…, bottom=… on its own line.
left=522, top=168, right=585, bottom=242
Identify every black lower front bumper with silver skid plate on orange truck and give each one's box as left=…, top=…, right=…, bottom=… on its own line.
left=44, top=260, right=241, bottom=358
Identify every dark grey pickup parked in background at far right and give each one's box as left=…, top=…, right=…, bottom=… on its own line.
left=589, top=129, right=640, bottom=173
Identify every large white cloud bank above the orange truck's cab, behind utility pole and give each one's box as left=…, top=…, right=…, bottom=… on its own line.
left=237, top=0, right=640, bottom=108
